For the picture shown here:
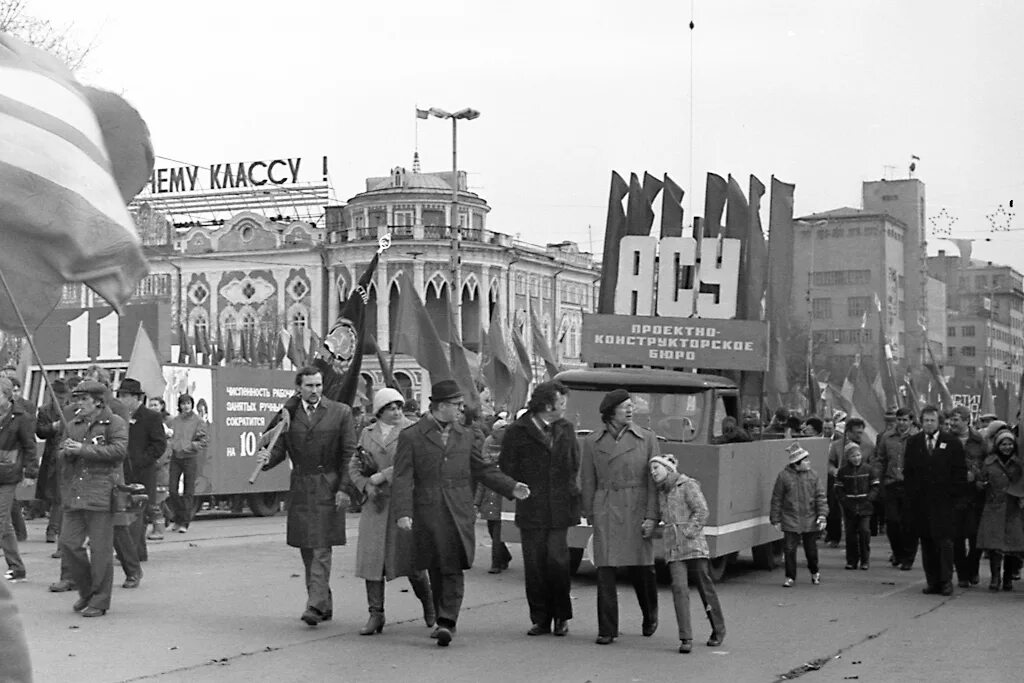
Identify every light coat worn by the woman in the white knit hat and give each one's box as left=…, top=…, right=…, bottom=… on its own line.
left=348, top=416, right=414, bottom=581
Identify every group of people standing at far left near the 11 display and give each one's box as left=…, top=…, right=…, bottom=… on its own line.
left=0, top=366, right=207, bottom=617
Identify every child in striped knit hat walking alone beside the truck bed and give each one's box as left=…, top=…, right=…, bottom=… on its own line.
left=768, top=441, right=828, bottom=588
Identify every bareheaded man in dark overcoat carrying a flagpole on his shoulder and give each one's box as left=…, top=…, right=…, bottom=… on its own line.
left=257, top=367, right=355, bottom=626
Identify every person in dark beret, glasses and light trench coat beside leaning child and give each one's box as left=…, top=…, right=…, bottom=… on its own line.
left=580, top=389, right=659, bottom=645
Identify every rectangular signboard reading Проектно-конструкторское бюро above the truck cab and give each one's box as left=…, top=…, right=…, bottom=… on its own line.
left=582, top=313, right=768, bottom=372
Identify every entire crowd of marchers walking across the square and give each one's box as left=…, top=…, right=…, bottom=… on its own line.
left=0, top=367, right=1024, bottom=679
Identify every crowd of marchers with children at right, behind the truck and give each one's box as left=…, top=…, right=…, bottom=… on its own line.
left=771, top=405, right=1024, bottom=595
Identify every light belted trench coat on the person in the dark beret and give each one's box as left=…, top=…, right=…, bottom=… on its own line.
left=580, top=424, right=660, bottom=567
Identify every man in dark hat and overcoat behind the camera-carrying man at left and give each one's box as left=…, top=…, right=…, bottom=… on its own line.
left=114, top=377, right=167, bottom=588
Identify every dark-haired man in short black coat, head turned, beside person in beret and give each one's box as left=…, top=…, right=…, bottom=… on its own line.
left=499, top=382, right=580, bottom=636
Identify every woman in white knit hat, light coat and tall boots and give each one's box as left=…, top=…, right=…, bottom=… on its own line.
left=348, top=388, right=435, bottom=636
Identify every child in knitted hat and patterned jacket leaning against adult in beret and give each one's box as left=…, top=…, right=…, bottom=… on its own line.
left=648, top=455, right=725, bottom=653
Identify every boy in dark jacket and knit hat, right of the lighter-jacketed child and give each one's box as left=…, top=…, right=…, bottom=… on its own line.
left=836, top=441, right=879, bottom=569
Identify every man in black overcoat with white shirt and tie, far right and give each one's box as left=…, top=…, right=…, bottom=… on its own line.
left=903, top=405, right=967, bottom=595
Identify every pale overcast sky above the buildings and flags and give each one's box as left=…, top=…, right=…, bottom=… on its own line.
left=39, top=0, right=1024, bottom=270
